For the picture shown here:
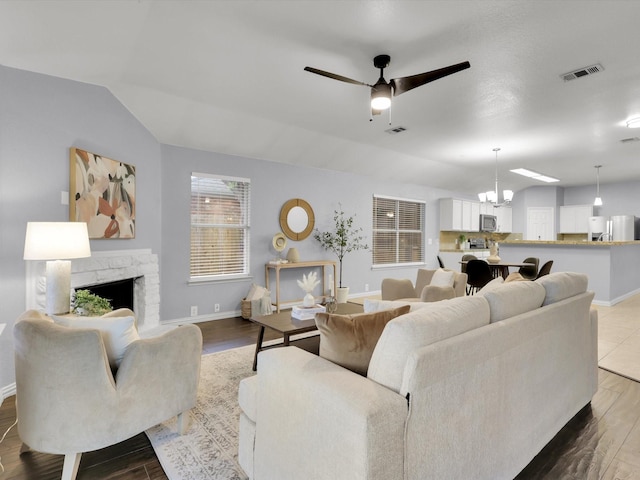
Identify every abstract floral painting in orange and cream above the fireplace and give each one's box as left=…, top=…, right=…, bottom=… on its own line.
left=69, top=147, right=136, bottom=238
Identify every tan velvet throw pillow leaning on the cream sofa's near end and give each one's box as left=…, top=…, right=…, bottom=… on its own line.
left=316, top=305, right=410, bottom=375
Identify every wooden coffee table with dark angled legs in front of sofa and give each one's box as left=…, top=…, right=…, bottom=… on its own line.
left=249, top=303, right=363, bottom=371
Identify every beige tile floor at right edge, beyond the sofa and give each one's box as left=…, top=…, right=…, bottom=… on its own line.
left=594, top=295, right=640, bottom=381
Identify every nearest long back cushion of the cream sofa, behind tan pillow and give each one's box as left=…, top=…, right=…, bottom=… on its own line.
left=367, top=296, right=489, bottom=392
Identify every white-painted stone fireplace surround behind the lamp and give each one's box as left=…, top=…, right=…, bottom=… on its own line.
left=26, top=249, right=160, bottom=330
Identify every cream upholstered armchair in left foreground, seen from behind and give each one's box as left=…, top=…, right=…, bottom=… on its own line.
left=14, top=310, right=202, bottom=480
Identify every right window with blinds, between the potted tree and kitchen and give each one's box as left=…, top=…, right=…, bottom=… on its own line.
left=372, top=196, right=424, bottom=266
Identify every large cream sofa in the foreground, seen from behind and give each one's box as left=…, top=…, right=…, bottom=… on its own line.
left=239, top=272, right=597, bottom=480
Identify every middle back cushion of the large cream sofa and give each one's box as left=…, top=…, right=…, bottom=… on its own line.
left=478, top=282, right=545, bottom=323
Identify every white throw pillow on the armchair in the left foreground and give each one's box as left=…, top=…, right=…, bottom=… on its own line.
left=53, top=315, right=140, bottom=369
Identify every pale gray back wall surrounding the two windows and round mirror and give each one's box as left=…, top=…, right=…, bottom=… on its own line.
left=161, top=146, right=455, bottom=320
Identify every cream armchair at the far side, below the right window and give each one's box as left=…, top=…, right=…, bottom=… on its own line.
left=381, top=268, right=467, bottom=302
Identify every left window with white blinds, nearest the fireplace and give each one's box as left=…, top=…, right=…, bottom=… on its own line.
left=190, top=173, right=251, bottom=280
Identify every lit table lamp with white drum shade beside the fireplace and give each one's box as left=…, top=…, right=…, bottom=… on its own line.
left=24, top=222, right=91, bottom=315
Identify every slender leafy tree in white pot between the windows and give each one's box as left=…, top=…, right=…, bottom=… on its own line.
left=313, top=205, right=369, bottom=303
